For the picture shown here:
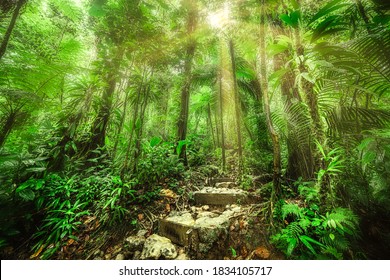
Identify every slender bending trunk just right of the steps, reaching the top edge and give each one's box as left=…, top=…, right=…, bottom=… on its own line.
left=260, top=0, right=281, bottom=201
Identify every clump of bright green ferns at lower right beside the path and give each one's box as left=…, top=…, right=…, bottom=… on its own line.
left=271, top=185, right=358, bottom=259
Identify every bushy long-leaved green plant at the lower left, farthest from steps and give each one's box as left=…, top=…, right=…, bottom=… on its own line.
left=15, top=174, right=89, bottom=259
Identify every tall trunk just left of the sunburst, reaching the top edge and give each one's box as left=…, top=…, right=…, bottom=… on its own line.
left=177, top=0, right=198, bottom=166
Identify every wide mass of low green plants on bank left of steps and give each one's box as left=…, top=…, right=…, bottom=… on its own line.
left=11, top=174, right=136, bottom=259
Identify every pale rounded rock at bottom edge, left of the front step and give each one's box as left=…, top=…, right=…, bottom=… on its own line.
left=140, top=234, right=177, bottom=260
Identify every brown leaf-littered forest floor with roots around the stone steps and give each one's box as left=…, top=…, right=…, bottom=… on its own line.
left=3, top=162, right=283, bottom=260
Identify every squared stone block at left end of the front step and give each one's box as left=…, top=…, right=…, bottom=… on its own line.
left=159, top=212, right=195, bottom=246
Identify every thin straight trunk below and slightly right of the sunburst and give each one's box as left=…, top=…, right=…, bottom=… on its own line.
left=229, top=40, right=242, bottom=173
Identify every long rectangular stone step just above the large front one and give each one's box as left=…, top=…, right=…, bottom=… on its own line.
left=194, top=187, right=259, bottom=205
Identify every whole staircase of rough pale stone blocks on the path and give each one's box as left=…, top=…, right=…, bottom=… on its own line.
left=158, top=177, right=260, bottom=259
